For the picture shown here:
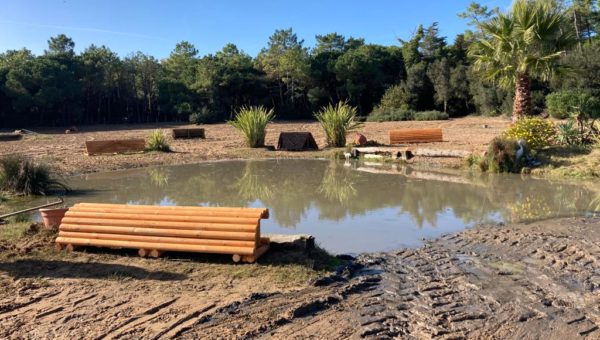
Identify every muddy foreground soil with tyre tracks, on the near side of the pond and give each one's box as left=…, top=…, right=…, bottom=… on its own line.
left=0, top=218, right=600, bottom=339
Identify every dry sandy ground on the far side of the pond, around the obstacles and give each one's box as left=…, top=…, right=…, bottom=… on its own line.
left=0, top=117, right=510, bottom=174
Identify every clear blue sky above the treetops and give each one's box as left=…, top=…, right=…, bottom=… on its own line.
left=0, top=0, right=511, bottom=59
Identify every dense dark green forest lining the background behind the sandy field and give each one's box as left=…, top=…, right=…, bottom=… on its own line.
left=0, top=0, right=600, bottom=127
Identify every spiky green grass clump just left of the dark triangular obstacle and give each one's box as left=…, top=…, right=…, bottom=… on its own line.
left=229, top=106, right=275, bottom=148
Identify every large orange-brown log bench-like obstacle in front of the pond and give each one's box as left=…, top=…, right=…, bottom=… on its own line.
left=56, top=203, right=269, bottom=263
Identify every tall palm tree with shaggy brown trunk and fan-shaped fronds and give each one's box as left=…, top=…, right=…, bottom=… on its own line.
left=470, top=0, right=576, bottom=121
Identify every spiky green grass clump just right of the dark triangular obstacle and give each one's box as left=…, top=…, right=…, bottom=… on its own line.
left=315, top=102, right=361, bottom=147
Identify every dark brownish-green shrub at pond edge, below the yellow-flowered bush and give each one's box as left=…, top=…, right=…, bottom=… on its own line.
left=479, top=137, right=525, bottom=173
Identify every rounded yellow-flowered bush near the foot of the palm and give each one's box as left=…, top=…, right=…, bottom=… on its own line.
left=504, top=118, right=556, bottom=149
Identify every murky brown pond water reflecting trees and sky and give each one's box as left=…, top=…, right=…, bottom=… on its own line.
left=39, top=160, right=596, bottom=253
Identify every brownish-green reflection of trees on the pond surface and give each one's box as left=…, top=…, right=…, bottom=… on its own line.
left=63, top=160, right=600, bottom=228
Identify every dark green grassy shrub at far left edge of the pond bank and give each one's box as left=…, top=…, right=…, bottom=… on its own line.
left=0, top=155, right=69, bottom=195
